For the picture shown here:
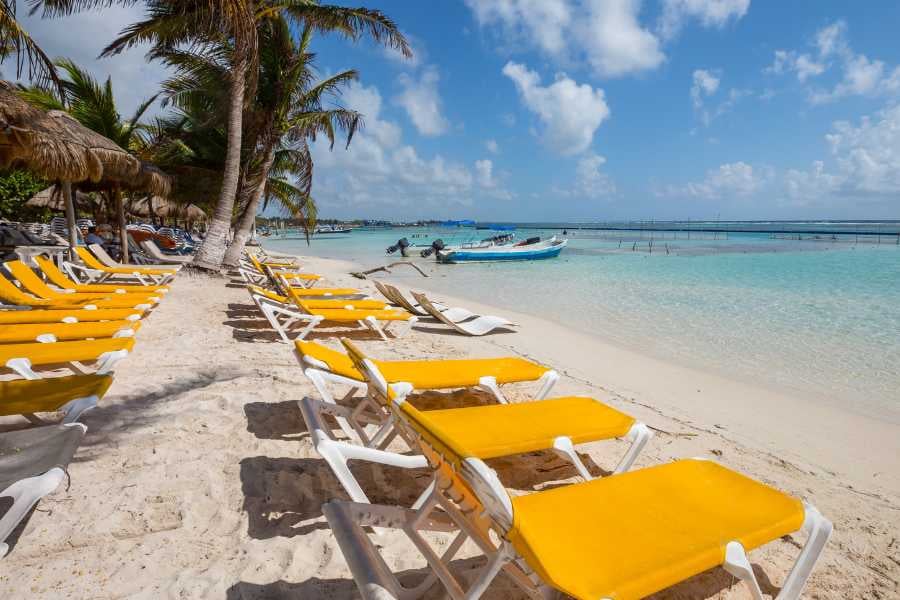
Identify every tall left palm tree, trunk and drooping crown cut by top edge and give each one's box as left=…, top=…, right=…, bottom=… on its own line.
left=101, top=0, right=411, bottom=269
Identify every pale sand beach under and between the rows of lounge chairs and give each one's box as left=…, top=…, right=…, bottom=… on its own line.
left=0, top=259, right=900, bottom=600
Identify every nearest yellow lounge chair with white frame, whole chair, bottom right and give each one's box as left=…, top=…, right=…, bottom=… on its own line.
left=323, top=394, right=832, bottom=600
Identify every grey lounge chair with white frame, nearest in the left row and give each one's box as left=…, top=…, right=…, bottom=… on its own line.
left=0, top=423, right=87, bottom=557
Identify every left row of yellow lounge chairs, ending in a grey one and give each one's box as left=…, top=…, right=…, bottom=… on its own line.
left=0, top=247, right=179, bottom=557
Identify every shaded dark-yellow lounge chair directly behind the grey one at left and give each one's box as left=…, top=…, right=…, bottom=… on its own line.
left=0, top=375, right=112, bottom=424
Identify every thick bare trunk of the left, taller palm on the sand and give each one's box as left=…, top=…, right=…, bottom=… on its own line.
left=192, top=54, right=247, bottom=271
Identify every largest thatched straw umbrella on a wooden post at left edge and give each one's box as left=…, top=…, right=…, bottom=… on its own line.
left=0, top=82, right=141, bottom=255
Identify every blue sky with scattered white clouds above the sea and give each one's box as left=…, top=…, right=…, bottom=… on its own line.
left=7, top=0, right=900, bottom=221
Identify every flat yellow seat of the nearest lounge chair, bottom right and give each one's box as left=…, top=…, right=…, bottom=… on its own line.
left=507, top=460, right=804, bottom=600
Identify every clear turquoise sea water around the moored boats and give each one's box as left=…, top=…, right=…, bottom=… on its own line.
left=264, top=229, right=900, bottom=423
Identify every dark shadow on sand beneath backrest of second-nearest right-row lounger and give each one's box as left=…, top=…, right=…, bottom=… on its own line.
left=241, top=456, right=431, bottom=540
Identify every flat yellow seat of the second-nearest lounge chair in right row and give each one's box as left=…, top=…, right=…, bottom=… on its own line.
left=401, top=397, right=634, bottom=459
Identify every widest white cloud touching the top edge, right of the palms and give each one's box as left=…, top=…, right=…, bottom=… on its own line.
left=466, top=0, right=665, bottom=77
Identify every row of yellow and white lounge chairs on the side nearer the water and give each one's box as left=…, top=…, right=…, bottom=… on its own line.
left=236, top=247, right=832, bottom=600
